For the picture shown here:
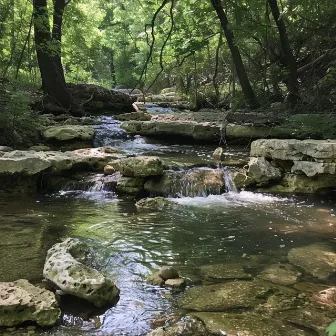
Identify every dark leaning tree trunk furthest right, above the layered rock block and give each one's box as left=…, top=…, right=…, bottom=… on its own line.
left=268, top=0, right=299, bottom=107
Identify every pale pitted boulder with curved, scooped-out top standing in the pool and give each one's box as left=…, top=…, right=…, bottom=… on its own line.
left=43, top=238, right=119, bottom=307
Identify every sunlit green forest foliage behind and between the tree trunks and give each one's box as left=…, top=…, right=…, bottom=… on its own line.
left=0, top=0, right=336, bottom=110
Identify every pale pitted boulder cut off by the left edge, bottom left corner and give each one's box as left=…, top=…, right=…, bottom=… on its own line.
left=0, top=280, right=61, bottom=327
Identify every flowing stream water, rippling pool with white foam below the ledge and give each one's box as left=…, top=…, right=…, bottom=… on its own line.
left=0, top=115, right=336, bottom=336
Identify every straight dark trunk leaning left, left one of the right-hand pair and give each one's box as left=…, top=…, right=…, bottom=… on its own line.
left=210, top=0, right=260, bottom=109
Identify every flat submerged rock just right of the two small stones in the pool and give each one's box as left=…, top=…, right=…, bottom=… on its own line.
left=200, top=264, right=252, bottom=281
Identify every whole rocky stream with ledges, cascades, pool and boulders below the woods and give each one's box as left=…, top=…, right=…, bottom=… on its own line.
left=0, top=106, right=336, bottom=336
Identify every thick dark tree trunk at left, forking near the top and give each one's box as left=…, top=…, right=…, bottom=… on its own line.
left=33, top=0, right=71, bottom=110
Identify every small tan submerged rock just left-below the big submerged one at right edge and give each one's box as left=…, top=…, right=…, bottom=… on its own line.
left=258, top=264, right=301, bottom=286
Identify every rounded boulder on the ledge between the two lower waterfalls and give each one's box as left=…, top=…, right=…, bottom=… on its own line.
left=109, top=156, right=163, bottom=177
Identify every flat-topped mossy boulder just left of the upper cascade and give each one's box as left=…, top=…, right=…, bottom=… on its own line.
left=42, top=125, right=95, bottom=141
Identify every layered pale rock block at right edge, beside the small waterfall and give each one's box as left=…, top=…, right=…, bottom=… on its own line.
left=249, top=139, right=336, bottom=193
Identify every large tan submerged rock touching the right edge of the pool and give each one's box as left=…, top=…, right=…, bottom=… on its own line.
left=288, top=243, right=336, bottom=280
